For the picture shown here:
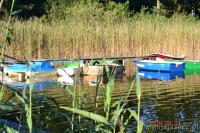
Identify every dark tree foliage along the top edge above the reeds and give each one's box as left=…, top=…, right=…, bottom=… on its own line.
left=3, top=0, right=200, bottom=19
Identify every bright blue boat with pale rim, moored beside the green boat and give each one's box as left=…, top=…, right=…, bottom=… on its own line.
left=134, top=60, right=185, bottom=72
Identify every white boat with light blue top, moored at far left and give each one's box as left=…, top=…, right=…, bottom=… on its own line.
left=3, top=61, right=57, bottom=81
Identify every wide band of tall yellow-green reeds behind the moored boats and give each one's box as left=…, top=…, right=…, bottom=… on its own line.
left=1, top=14, right=200, bottom=59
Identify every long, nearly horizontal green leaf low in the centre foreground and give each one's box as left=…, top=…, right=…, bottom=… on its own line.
left=60, top=106, right=108, bottom=124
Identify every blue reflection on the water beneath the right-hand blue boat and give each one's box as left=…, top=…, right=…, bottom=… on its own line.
left=139, top=70, right=185, bottom=80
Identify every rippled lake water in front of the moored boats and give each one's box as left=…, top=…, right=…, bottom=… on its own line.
left=3, top=72, right=200, bottom=133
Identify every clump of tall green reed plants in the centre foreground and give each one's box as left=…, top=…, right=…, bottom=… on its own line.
left=60, top=60, right=143, bottom=133
